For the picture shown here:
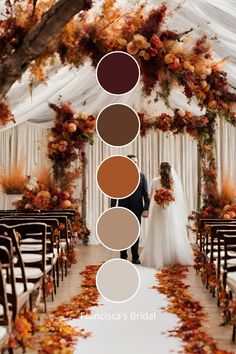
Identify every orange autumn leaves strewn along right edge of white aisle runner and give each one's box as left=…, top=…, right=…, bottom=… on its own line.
left=152, top=266, right=233, bottom=354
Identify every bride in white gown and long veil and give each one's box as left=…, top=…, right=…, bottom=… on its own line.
left=140, top=162, right=193, bottom=269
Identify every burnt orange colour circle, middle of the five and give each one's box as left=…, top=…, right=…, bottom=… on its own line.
left=97, top=155, right=140, bottom=198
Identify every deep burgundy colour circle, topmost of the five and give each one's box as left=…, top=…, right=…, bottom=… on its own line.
left=96, top=51, right=140, bottom=95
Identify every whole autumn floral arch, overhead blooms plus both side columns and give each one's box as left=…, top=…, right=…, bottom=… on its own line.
left=0, top=0, right=236, bottom=241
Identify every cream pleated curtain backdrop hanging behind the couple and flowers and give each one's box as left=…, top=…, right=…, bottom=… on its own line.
left=0, top=121, right=236, bottom=243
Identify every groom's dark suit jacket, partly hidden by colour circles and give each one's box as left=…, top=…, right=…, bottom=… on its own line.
left=111, top=173, right=150, bottom=220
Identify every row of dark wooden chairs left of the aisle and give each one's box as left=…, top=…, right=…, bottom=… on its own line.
left=0, top=211, right=77, bottom=352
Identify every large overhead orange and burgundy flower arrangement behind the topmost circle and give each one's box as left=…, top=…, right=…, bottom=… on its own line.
left=58, top=0, right=236, bottom=125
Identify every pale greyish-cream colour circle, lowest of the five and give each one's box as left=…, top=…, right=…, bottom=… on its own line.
left=96, top=258, right=140, bottom=302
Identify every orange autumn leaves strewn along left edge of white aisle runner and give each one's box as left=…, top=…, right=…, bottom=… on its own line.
left=8, top=265, right=100, bottom=354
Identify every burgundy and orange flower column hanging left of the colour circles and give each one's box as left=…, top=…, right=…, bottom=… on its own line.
left=48, top=103, right=96, bottom=242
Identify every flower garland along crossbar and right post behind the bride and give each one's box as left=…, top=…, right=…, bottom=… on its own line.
left=139, top=109, right=218, bottom=215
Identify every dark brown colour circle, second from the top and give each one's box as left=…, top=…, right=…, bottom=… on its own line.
left=96, top=103, right=140, bottom=146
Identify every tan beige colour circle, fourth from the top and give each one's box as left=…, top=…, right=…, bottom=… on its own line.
left=96, top=207, right=140, bottom=251
